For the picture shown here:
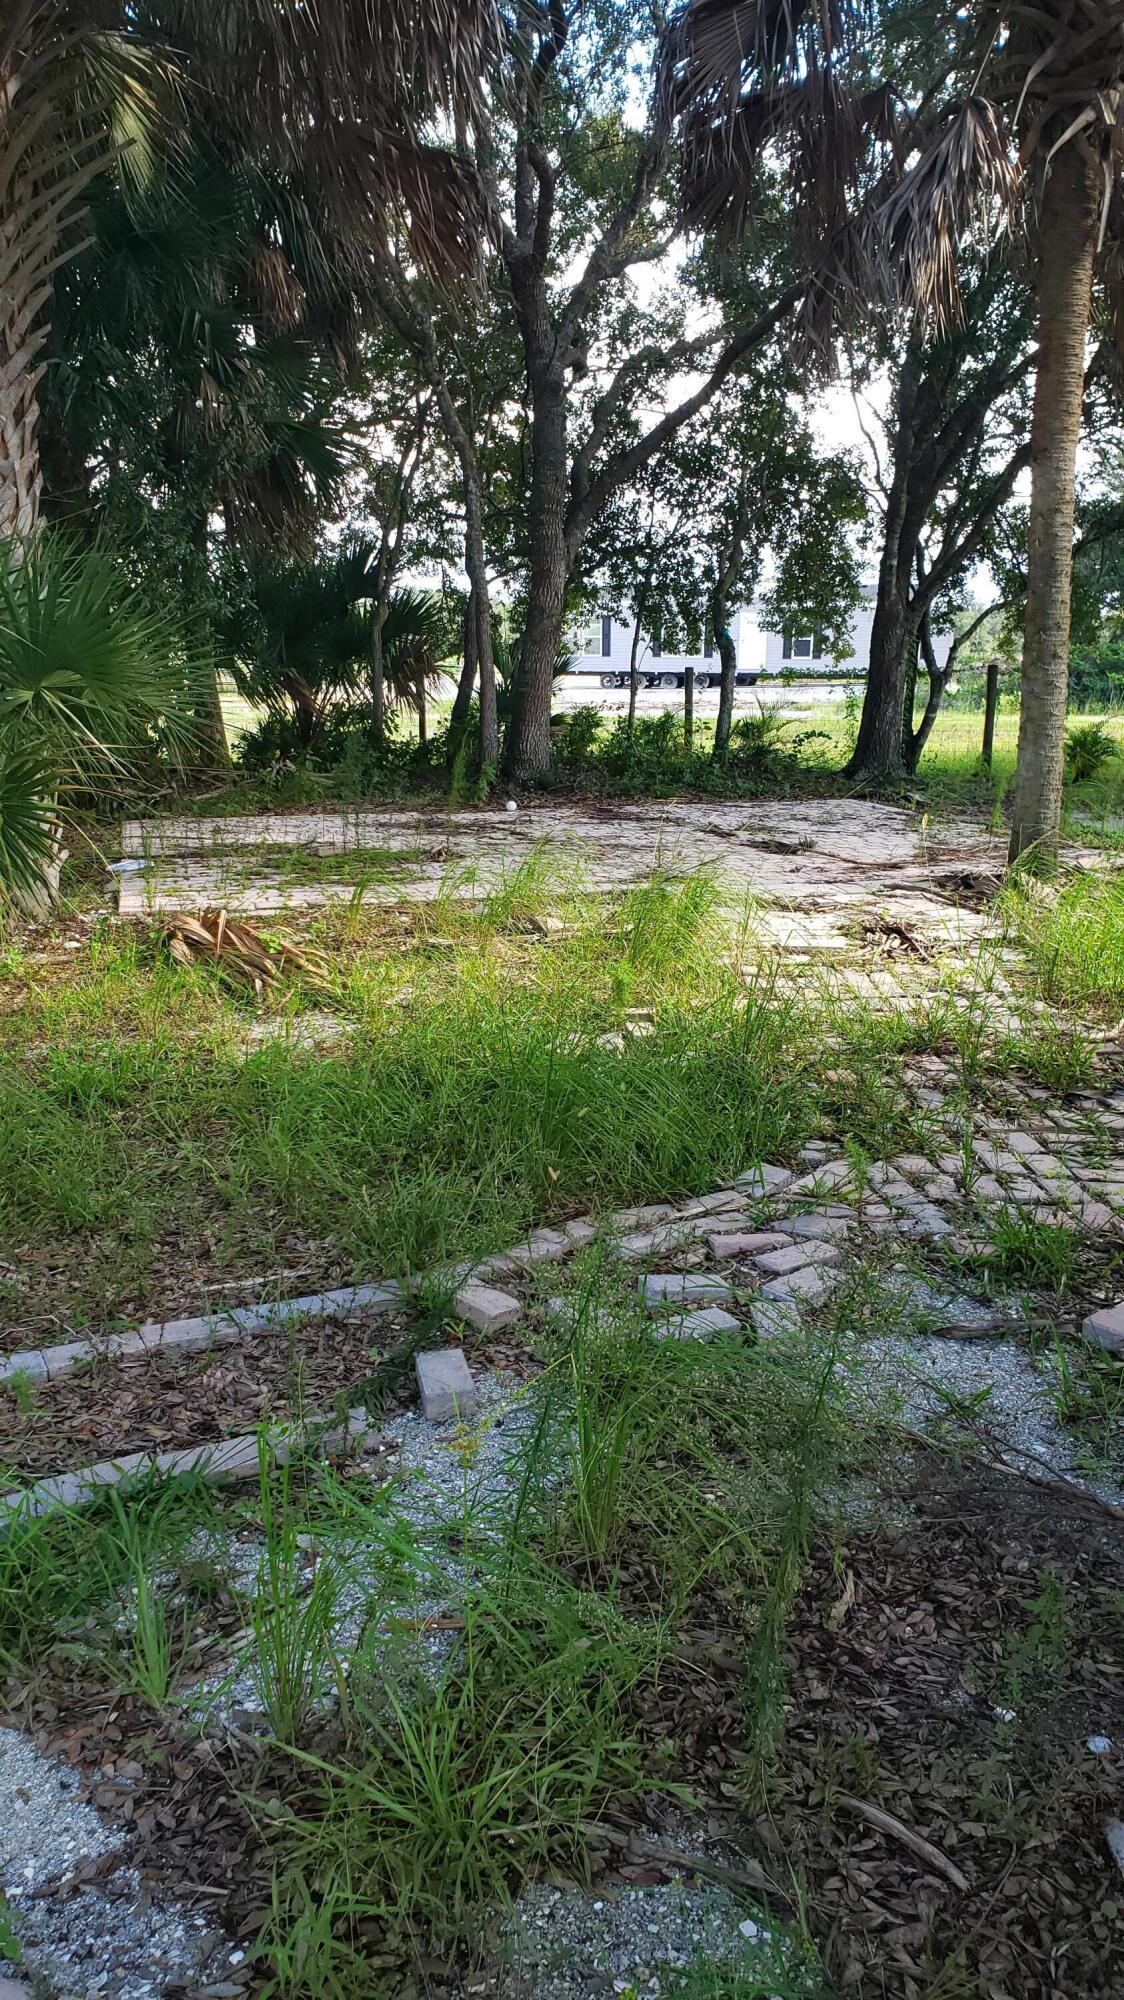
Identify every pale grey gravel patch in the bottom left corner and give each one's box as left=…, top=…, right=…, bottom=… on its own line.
left=0, top=1730, right=228, bottom=2000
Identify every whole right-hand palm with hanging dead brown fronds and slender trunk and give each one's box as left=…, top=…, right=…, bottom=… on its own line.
left=664, top=0, right=1124, bottom=860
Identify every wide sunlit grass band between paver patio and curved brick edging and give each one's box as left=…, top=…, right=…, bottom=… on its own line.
left=0, top=852, right=1120, bottom=1328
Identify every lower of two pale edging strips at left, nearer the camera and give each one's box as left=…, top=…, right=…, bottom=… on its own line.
left=0, top=1410, right=382, bottom=1526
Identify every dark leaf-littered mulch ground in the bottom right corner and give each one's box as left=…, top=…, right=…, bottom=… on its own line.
left=758, top=1462, right=1124, bottom=2000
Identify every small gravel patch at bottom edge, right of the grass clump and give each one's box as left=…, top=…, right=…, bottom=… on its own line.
left=490, top=1882, right=782, bottom=2000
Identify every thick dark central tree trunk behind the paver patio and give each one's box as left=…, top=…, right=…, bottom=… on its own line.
left=504, top=362, right=570, bottom=784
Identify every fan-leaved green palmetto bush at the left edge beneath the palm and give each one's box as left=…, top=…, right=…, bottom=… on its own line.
left=0, top=534, right=194, bottom=910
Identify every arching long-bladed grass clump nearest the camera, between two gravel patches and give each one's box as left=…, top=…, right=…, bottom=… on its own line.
left=262, top=1546, right=650, bottom=1968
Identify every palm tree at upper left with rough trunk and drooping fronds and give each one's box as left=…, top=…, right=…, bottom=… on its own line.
left=0, top=0, right=500, bottom=556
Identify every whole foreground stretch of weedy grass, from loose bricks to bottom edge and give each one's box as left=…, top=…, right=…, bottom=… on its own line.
left=260, top=1288, right=866, bottom=2000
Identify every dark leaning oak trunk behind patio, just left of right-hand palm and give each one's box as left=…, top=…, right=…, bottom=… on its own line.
left=846, top=348, right=920, bottom=784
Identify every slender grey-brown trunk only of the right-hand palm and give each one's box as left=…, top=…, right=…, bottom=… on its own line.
left=1008, top=136, right=1098, bottom=868
